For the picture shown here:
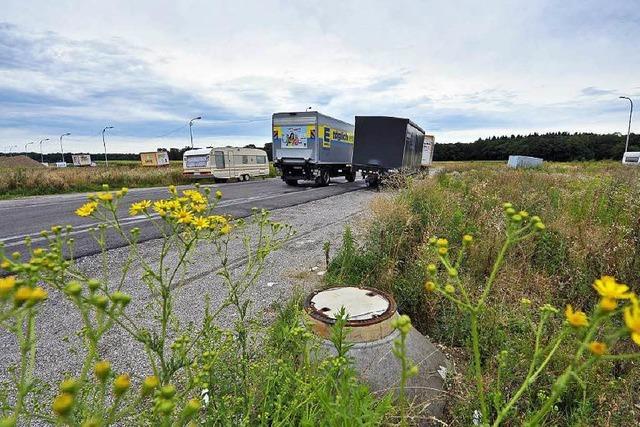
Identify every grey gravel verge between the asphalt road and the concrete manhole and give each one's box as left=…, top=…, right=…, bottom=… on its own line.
left=0, top=187, right=377, bottom=384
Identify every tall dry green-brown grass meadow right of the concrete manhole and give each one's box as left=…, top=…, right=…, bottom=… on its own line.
left=327, top=162, right=640, bottom=425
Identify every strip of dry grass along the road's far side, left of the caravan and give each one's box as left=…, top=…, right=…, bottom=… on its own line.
left=0, top=161, right=275, bottom=199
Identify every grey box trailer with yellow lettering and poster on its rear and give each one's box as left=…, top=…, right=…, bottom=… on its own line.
left=272, top=111, right=356, bottom=185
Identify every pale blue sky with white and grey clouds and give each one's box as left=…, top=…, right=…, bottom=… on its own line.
left=0, top=0, right=640, bottom=153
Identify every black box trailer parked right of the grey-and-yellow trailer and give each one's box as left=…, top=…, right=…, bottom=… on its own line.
left=352, top=116, right=425, bottom=186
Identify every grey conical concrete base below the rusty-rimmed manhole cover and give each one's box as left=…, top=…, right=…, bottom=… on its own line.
left=322, top=328, right=451, bottom=425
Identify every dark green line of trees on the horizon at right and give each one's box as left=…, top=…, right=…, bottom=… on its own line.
left=433, top=132, right=640, bottom=162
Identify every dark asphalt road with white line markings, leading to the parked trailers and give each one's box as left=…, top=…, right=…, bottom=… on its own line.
left=0, top=178, right=365, bottom=258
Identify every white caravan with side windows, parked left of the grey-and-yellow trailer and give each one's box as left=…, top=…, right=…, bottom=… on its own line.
left=182, top=147, right=269, bottom=181
